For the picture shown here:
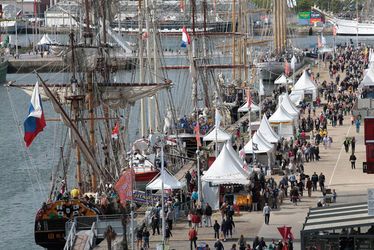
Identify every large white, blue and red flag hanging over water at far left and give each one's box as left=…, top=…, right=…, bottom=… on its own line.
left=23, top=82, right=46, bottom=147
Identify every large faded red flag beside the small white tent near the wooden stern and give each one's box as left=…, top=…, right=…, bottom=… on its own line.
left=114, top=168, right=135, bottom=204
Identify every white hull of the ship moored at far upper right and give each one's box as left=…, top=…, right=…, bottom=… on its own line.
left=334, top=19, right=374, bottom=36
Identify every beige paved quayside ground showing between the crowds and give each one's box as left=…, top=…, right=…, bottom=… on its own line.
left=145, top=67, right=374, bottom=249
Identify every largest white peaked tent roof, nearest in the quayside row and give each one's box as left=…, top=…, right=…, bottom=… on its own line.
left=201, top=146, right=250, bottom=185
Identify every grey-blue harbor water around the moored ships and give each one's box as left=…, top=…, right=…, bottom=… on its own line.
left=0, top=33, right=374, bottom=250
